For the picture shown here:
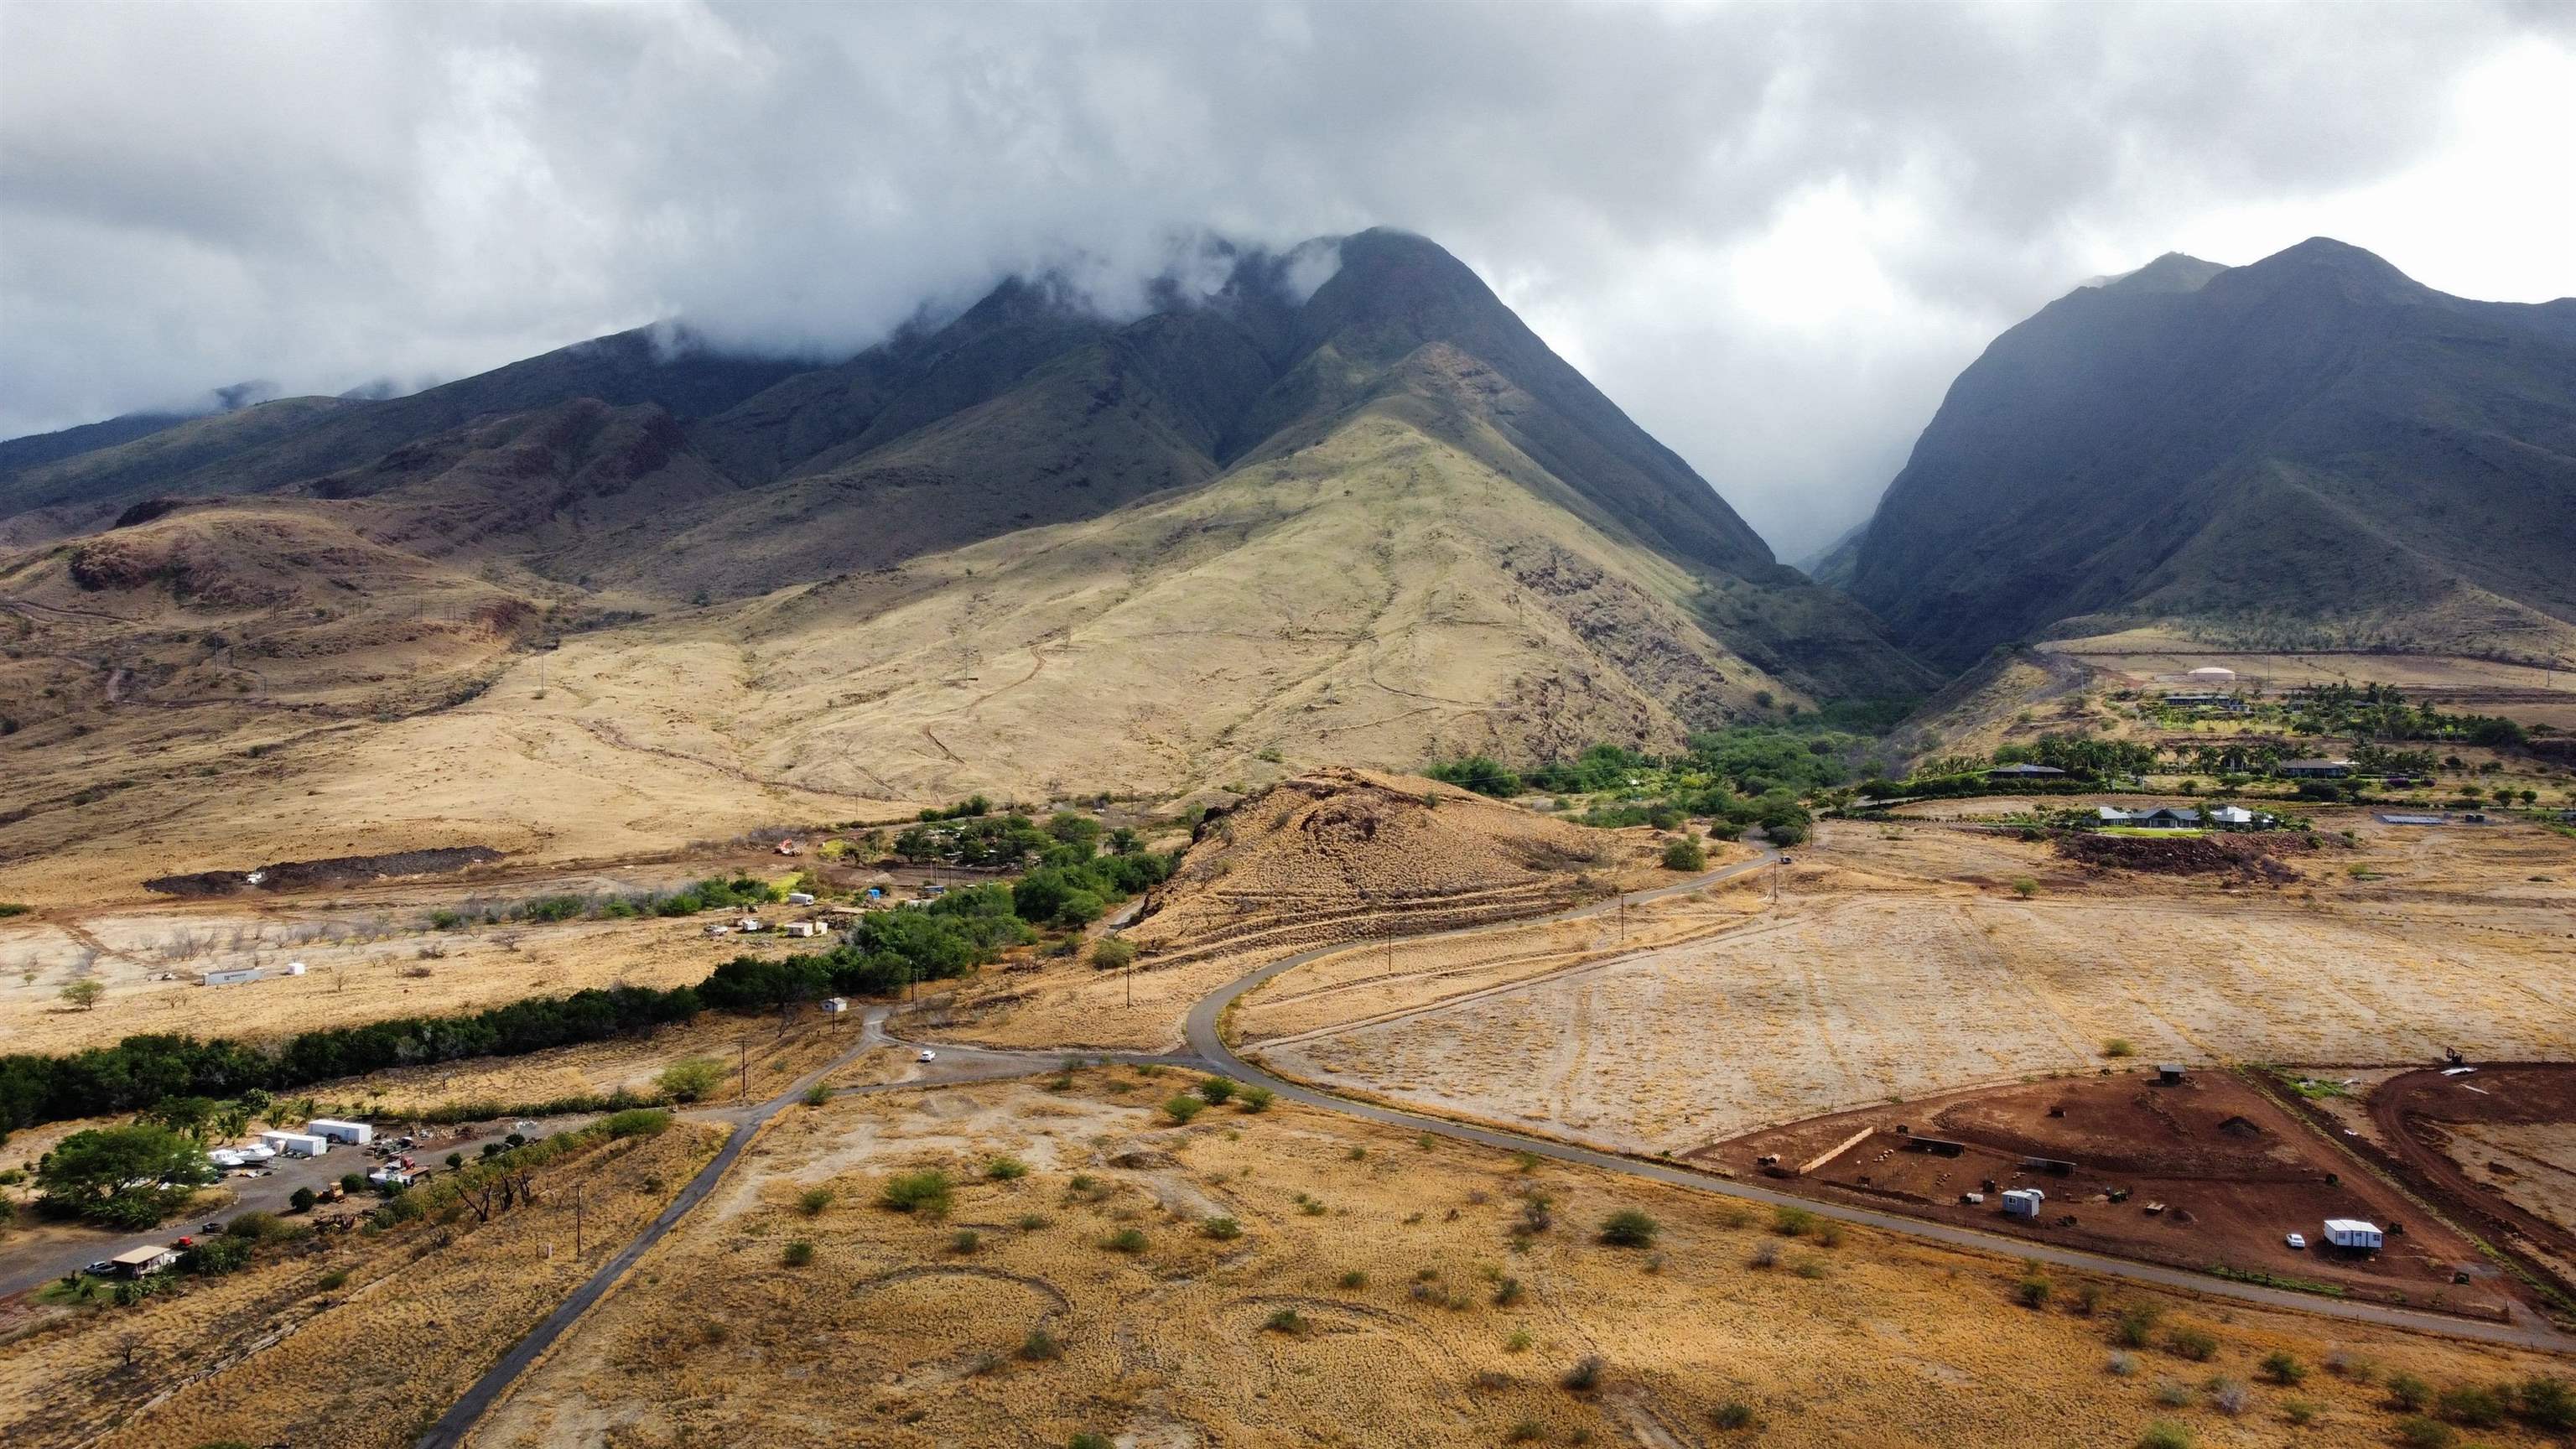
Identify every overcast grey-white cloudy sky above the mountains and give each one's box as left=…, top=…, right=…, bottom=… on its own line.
left=0, top=0, right=2576, bottom=557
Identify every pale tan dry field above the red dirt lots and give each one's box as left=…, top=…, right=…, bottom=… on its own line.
left=1242, top=820, right=2576, bottom=1152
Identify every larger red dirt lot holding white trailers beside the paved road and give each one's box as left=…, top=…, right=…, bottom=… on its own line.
left=1692, top=1070, right=2514, bottom=1317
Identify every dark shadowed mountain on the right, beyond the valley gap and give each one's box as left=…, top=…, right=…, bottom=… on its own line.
left=1850, top=240, right=2576, bottom=665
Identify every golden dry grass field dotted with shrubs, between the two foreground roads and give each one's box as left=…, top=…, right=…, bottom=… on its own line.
left=474, top=1070, right=2553, bottom=1449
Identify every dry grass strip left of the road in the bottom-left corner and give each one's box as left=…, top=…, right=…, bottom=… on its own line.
left=0, top=1109, right=724, bottom=1449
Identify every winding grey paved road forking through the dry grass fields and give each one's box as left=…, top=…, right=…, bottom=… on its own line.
left=418, top=851, right=2576, bottom=1449
